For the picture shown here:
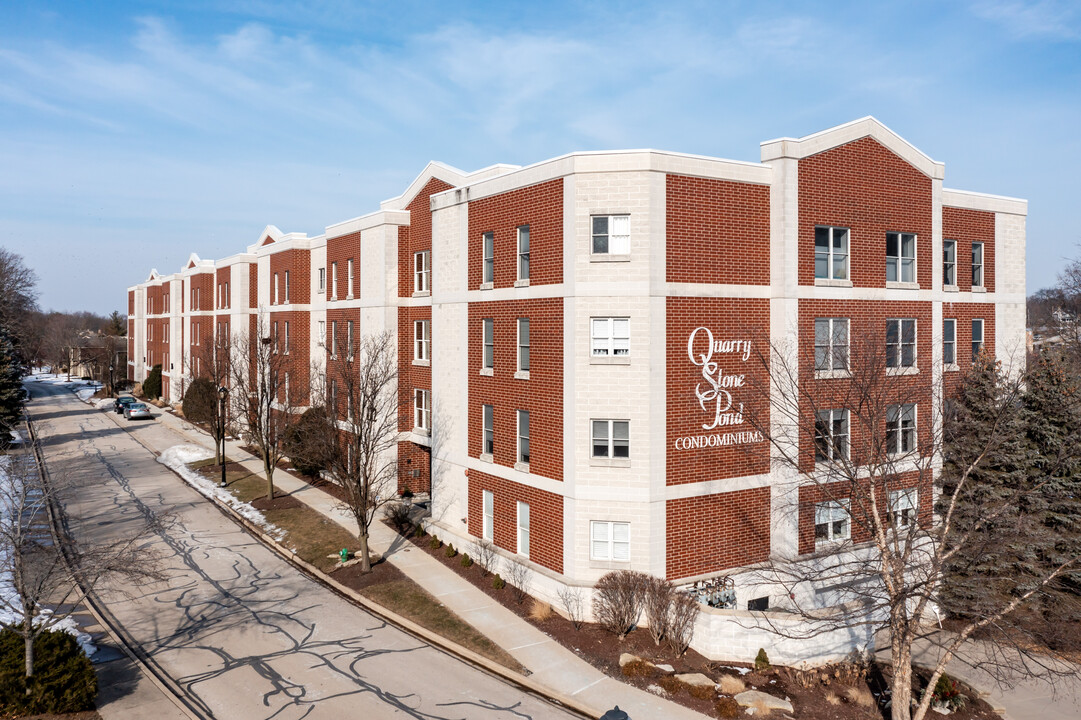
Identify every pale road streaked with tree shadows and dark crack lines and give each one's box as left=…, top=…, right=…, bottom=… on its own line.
left=27, top=383, right=576, bottom=720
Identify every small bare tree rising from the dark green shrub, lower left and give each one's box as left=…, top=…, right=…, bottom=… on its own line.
left=0, top=452, right=164, bottom=679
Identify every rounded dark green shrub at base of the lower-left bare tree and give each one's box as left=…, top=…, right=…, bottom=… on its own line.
left=0, top=629, right=97, bottom=715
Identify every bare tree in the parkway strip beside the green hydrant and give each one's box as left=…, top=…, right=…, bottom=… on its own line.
left=312, top=332, right=401, bottom=572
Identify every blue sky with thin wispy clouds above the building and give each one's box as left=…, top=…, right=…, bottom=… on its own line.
left=0, top=0, right=1081, bottom=312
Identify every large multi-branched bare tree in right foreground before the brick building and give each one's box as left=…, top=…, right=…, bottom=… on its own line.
left=746, top=326, right=1078, bottom=720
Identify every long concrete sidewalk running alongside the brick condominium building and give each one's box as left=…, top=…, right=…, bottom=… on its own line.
left=145, top=412, right=703, bottom=720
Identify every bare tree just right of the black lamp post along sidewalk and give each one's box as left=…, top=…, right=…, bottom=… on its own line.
left=227, top=314, right=307, bottom=499
